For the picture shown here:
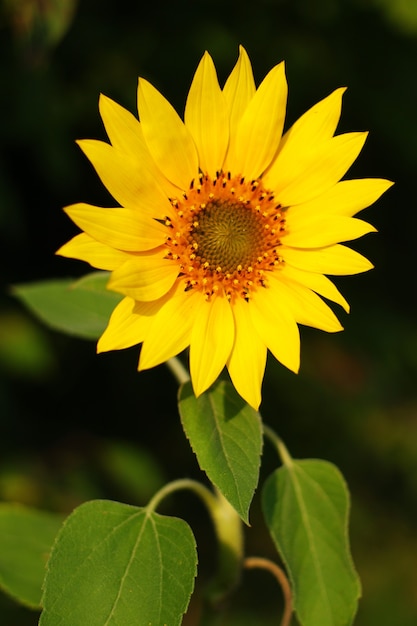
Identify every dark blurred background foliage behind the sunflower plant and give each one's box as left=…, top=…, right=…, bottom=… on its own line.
left=0, top=0, right=417, bottom=626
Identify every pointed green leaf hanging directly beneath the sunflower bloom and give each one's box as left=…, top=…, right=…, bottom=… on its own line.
left=179, top=381, right=262, bottom=523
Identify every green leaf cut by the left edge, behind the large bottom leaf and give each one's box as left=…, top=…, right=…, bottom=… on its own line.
left=0, top=504, right=63, bottom=608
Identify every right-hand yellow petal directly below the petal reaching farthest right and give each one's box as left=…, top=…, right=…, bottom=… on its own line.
left=282, top=209, right=376, bottom=248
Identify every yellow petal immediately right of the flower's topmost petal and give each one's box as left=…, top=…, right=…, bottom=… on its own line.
left=228, top=63, right=288, bottom=180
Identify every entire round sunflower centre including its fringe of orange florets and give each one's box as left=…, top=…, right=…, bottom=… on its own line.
left=165, top=172, right=286, bottom=301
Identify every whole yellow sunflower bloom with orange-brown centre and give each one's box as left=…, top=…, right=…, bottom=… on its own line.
left=58, top=48, right=391, bottom=409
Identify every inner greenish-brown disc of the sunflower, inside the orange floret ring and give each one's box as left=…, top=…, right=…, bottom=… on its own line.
left=190, top=199, right=263, bottom=273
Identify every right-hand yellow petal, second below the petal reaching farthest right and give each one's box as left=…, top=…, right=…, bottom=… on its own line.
left=280, top=245, right=373, bottom=276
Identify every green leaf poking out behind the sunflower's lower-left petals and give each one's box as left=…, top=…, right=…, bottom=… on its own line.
left=13, top=272, right=122, bottom=339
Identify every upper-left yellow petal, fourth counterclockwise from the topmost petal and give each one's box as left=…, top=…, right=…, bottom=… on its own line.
left=77, top=139, right=171, bottom=218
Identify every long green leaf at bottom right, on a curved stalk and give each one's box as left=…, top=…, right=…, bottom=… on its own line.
left=262, top=458, right=360, bottom=626
